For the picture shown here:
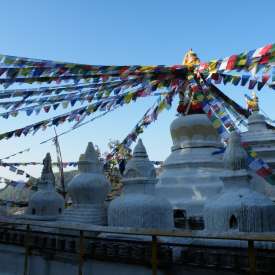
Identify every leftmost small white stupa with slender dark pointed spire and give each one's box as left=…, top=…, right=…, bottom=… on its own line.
left=26, top=153, right=64, bottom=220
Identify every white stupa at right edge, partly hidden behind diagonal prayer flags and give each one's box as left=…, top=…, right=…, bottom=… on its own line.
left=242, top=111, right=275, bottom=200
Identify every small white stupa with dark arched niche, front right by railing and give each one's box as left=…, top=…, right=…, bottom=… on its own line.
left=204, top=132, right=275, bottom=232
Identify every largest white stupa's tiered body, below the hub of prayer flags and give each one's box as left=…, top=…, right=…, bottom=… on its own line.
left=156, top=114, right=224, bottom=217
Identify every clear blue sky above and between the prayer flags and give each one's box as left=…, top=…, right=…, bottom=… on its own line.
left=0, top=0, right=275, bottom=181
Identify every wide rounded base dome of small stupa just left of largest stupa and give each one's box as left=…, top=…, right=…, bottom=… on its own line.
left=108, top=194, right=174, bottom=229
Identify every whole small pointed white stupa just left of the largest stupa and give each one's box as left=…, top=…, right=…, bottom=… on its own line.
left=108, top=140, right=174, bottom=229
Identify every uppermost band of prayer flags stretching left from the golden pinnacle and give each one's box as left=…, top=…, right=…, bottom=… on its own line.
left=0, top=51, right=190, bottom=86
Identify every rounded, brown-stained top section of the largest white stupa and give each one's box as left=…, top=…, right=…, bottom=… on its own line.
left=170, top=114, right=221, bottom=150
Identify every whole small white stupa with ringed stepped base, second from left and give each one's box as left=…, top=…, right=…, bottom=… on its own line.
left=61, top=142, right=110, bottom=225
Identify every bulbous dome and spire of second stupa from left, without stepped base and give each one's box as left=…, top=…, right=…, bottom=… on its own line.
left=68, top=142, right=109, bottom=204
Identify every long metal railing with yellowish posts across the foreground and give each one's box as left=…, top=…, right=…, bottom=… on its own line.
left=0, top=217, right=275, bottom=275
